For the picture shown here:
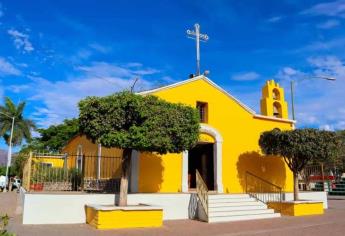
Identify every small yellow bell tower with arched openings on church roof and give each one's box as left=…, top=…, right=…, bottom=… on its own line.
left=260, top=80, right=288, bottom=119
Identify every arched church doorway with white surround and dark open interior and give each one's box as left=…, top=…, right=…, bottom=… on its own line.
left=182, top=124, right=223, bottom=193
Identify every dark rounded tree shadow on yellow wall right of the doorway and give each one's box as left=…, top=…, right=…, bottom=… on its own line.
left=237, top=151, right=286, bottom=192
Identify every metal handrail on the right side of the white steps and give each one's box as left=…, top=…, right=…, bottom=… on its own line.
left=246, top=171, right=282, bottom=210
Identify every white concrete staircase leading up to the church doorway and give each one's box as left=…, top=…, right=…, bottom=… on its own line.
left=208, top=194, right=280, bottom=223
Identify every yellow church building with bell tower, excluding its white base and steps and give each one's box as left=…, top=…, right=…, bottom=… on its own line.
left=63, top=75, right=295, bottom=193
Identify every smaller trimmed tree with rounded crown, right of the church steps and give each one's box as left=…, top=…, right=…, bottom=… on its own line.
left=259, top=129, right=340, bottom=201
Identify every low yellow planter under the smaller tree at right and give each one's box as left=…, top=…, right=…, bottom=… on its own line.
left=268, top=201, right=324, bottom=216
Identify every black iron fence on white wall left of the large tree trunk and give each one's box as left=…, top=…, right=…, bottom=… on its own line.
left=28, top=153, right=121, bottom=193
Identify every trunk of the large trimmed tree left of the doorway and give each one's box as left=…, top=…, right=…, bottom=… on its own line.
left=119, top=148, right=132, bottom=206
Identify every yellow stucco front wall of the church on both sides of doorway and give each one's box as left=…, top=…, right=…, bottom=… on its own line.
left=139, top=79, right=293, bottom=193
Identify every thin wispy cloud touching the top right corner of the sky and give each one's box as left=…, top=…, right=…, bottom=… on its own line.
left=301, top=0, right=345, bottom=18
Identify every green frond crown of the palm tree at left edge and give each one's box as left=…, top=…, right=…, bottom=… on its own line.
left=0, top=97, right=36, bottom=146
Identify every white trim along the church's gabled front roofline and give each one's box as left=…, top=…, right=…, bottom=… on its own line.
left=137, top=75, right=296, bottom=123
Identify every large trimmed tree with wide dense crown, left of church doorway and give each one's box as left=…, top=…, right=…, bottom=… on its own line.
left=79, top=92, right=199, bottom=206
